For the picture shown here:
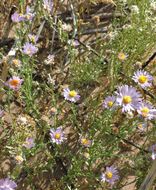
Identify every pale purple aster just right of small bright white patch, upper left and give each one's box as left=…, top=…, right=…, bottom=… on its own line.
left=23, top=42, right=38, bottom=56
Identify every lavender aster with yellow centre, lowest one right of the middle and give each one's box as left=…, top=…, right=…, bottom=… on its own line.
left=101, top=166, right=119, bottom=185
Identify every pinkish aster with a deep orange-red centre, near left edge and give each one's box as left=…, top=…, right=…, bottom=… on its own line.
left=6, top=76, right=23, bottom=91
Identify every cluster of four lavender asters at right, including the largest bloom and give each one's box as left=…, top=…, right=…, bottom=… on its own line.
left=103, top=70, right=156, bottom=120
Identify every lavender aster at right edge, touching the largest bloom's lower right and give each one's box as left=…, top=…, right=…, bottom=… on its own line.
left=137, top=102, right=156, bottom=120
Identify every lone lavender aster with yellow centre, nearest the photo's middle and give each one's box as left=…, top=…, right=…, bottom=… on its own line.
left=63, top=88, right=80, bottom=102
